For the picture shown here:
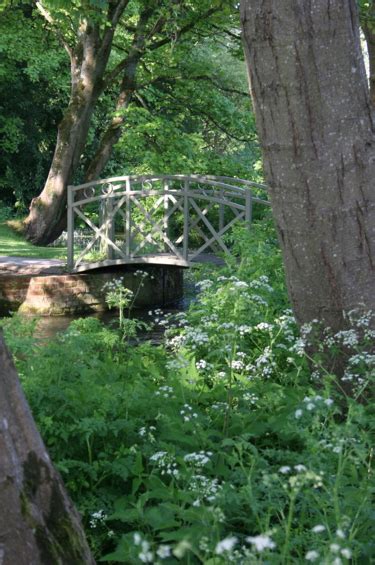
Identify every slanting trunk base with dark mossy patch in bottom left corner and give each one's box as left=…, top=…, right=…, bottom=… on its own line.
left=0, top=335, right=94, bottom=565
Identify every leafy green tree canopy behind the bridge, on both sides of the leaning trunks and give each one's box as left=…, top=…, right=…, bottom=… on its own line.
left=0, top=0, right=261, bottom=213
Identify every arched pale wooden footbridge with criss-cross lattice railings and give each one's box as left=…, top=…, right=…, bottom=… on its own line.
left=68, top=175, right=269, bottom=272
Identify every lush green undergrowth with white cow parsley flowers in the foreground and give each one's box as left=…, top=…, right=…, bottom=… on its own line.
left=6, top=225, right=375, bottom=565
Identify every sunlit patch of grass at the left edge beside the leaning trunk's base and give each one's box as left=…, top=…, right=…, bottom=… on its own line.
left=0, top=222, right=66, bottom=259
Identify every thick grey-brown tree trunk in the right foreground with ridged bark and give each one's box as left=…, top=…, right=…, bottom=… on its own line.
left=241, top=0, right=375, bottom=328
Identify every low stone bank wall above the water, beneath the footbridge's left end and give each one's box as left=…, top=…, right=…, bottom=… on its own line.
left=0, top=265, right=183, bottom=316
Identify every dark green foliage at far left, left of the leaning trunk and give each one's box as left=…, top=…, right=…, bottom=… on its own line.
left=0, top=5, right=68, bottom=208
